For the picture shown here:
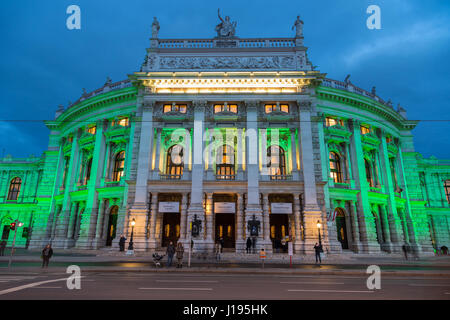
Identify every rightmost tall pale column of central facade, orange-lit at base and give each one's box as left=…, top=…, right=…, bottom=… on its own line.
left=297, top=100, right=328, bottom=252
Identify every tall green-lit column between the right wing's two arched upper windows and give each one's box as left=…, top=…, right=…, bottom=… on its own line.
left=350, top=120, right=380, bottom=253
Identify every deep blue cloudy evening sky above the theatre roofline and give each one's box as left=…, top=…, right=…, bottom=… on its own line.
left=0, top=0, right=450, bottom=159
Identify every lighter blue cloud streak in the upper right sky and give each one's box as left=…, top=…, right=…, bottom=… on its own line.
left=342, top=17, right=450, bottom=66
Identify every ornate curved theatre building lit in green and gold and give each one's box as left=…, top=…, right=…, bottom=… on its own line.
left=0, top=18, right=450, bottom=255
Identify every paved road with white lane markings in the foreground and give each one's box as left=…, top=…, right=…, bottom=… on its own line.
left=0, top=271, right=450, bottom=300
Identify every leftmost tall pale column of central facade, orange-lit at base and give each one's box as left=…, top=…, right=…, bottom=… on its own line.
left=128, top=96, right=155, bottom=251
